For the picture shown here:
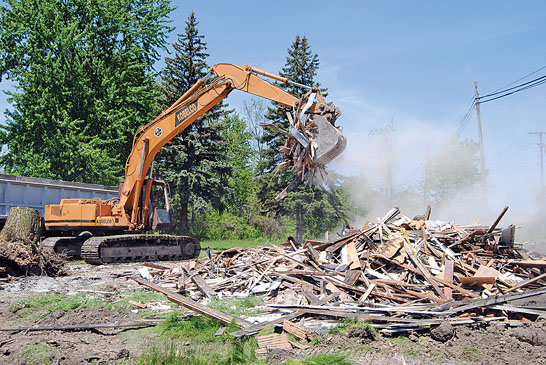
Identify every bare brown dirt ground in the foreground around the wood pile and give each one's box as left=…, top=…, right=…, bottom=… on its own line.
left=0, top=262, right=546, bottom=364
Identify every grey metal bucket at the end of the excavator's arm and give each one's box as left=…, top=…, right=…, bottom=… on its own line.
left=312, top=115, right=347, bottom=166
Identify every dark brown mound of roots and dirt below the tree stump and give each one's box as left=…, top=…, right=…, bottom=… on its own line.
left=0, top=239, right=65, bottom=277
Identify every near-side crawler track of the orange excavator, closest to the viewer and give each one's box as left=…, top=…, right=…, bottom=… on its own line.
left=81, top=234, right=201, bottom=265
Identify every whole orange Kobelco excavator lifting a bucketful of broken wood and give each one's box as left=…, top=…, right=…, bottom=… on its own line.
left=42, top=63, right=346, bottom=264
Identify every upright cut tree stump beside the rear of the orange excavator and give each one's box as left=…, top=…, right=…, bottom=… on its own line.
left=0, top=207, right=42, bottom=243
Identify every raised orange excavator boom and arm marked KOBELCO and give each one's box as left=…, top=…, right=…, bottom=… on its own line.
left=112, top=63, right=345, bottom=229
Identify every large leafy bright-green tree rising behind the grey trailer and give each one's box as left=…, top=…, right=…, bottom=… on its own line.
left=0, top=0, right=172, bottom=184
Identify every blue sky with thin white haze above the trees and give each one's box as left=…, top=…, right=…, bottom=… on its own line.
left=0, top=0, right=546, bottom=228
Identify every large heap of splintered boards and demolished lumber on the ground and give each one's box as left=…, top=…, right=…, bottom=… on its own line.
left=133, top=208, right=546, bottom=336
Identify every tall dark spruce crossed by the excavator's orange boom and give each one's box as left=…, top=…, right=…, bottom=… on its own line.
left=156, top=12, right=231, bottom=235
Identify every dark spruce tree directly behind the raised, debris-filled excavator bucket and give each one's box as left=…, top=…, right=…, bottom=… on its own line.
left=258, top=35, right=343, bottom=240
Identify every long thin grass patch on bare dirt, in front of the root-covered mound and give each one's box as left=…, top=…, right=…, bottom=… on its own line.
left=11, top=294, right=105, bottom=320
